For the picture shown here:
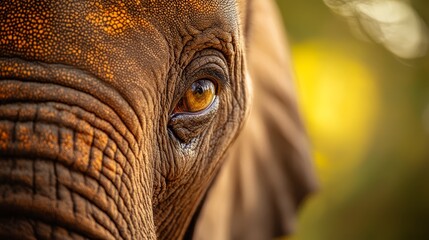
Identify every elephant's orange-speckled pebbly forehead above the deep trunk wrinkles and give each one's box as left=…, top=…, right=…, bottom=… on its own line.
left=0, top=0, right=238, bottom=78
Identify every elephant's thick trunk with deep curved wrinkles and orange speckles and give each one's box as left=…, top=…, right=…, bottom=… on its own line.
left=0, top=66, right=155, bottom=239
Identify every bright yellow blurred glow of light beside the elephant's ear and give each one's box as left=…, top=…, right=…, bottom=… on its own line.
left=293, top=40, right=378, bottom=184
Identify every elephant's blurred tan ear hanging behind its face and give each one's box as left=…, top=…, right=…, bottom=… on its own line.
left=194, top=0, right=317, bottom=239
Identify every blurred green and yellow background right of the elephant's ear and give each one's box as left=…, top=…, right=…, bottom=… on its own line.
left=277, top=0, right=429, bottom=240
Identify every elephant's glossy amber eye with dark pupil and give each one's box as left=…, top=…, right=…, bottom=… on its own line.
left=174, top=79, right=216, bottom=113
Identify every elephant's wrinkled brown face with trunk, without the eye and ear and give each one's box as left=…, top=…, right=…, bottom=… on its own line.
left=0, top=0, right=249, bottom=239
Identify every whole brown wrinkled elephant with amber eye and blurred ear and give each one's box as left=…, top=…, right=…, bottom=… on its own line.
left=0, top=0, right=317, bottom=239
